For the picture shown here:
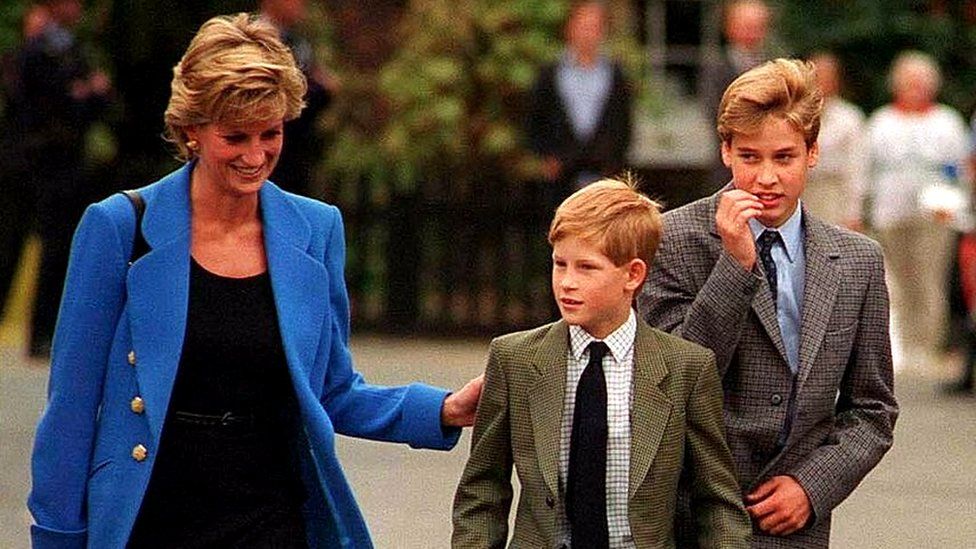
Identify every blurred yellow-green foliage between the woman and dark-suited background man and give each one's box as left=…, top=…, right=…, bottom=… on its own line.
left=327, top=0, right=640, bottom=191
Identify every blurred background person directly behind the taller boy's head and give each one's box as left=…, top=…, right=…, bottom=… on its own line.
left=698, top=0, right=773, bottom=189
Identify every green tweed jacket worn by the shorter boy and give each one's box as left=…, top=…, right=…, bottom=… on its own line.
left=452, top=321, right=752, bottom=549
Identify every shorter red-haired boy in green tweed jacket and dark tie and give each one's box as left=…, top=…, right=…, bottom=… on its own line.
left=452, top=180, right=750, bottom=549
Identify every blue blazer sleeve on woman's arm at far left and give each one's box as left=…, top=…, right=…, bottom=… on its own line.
left=27, top=204, right=131, bottom=548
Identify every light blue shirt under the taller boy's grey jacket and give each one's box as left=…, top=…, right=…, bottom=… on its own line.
left=749, top=207, right=806, bottom=373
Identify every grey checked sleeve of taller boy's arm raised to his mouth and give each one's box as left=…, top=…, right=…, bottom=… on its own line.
left=638, top=218, right=762, bottom=376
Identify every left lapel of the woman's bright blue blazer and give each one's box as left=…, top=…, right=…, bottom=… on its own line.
left=126, top=164, right=192, bottom=446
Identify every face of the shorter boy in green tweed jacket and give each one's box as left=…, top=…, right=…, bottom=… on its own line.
left=552, top=236, right=647, bottom=339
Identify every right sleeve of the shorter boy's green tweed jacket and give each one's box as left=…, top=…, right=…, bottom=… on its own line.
left=685, top=353, right=752, bottom=549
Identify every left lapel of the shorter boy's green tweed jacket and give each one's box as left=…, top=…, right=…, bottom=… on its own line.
left=529, top=320, right=569, bottom=494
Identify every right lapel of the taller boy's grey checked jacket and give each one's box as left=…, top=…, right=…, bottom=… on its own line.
left=798, top=212, right=840, bottom=387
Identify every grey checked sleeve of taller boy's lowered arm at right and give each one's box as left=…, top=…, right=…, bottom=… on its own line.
left=789, top=251, right=898, bottom=520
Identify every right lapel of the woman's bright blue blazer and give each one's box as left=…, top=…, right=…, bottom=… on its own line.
left=261, top=183, right=328, bottom=389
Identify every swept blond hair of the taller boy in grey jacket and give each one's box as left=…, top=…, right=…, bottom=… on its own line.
left=718, top=59, right=823, bottom=147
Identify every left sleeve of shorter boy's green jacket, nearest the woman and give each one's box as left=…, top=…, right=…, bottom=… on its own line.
left=451, top=342, right=513, bottom=549
